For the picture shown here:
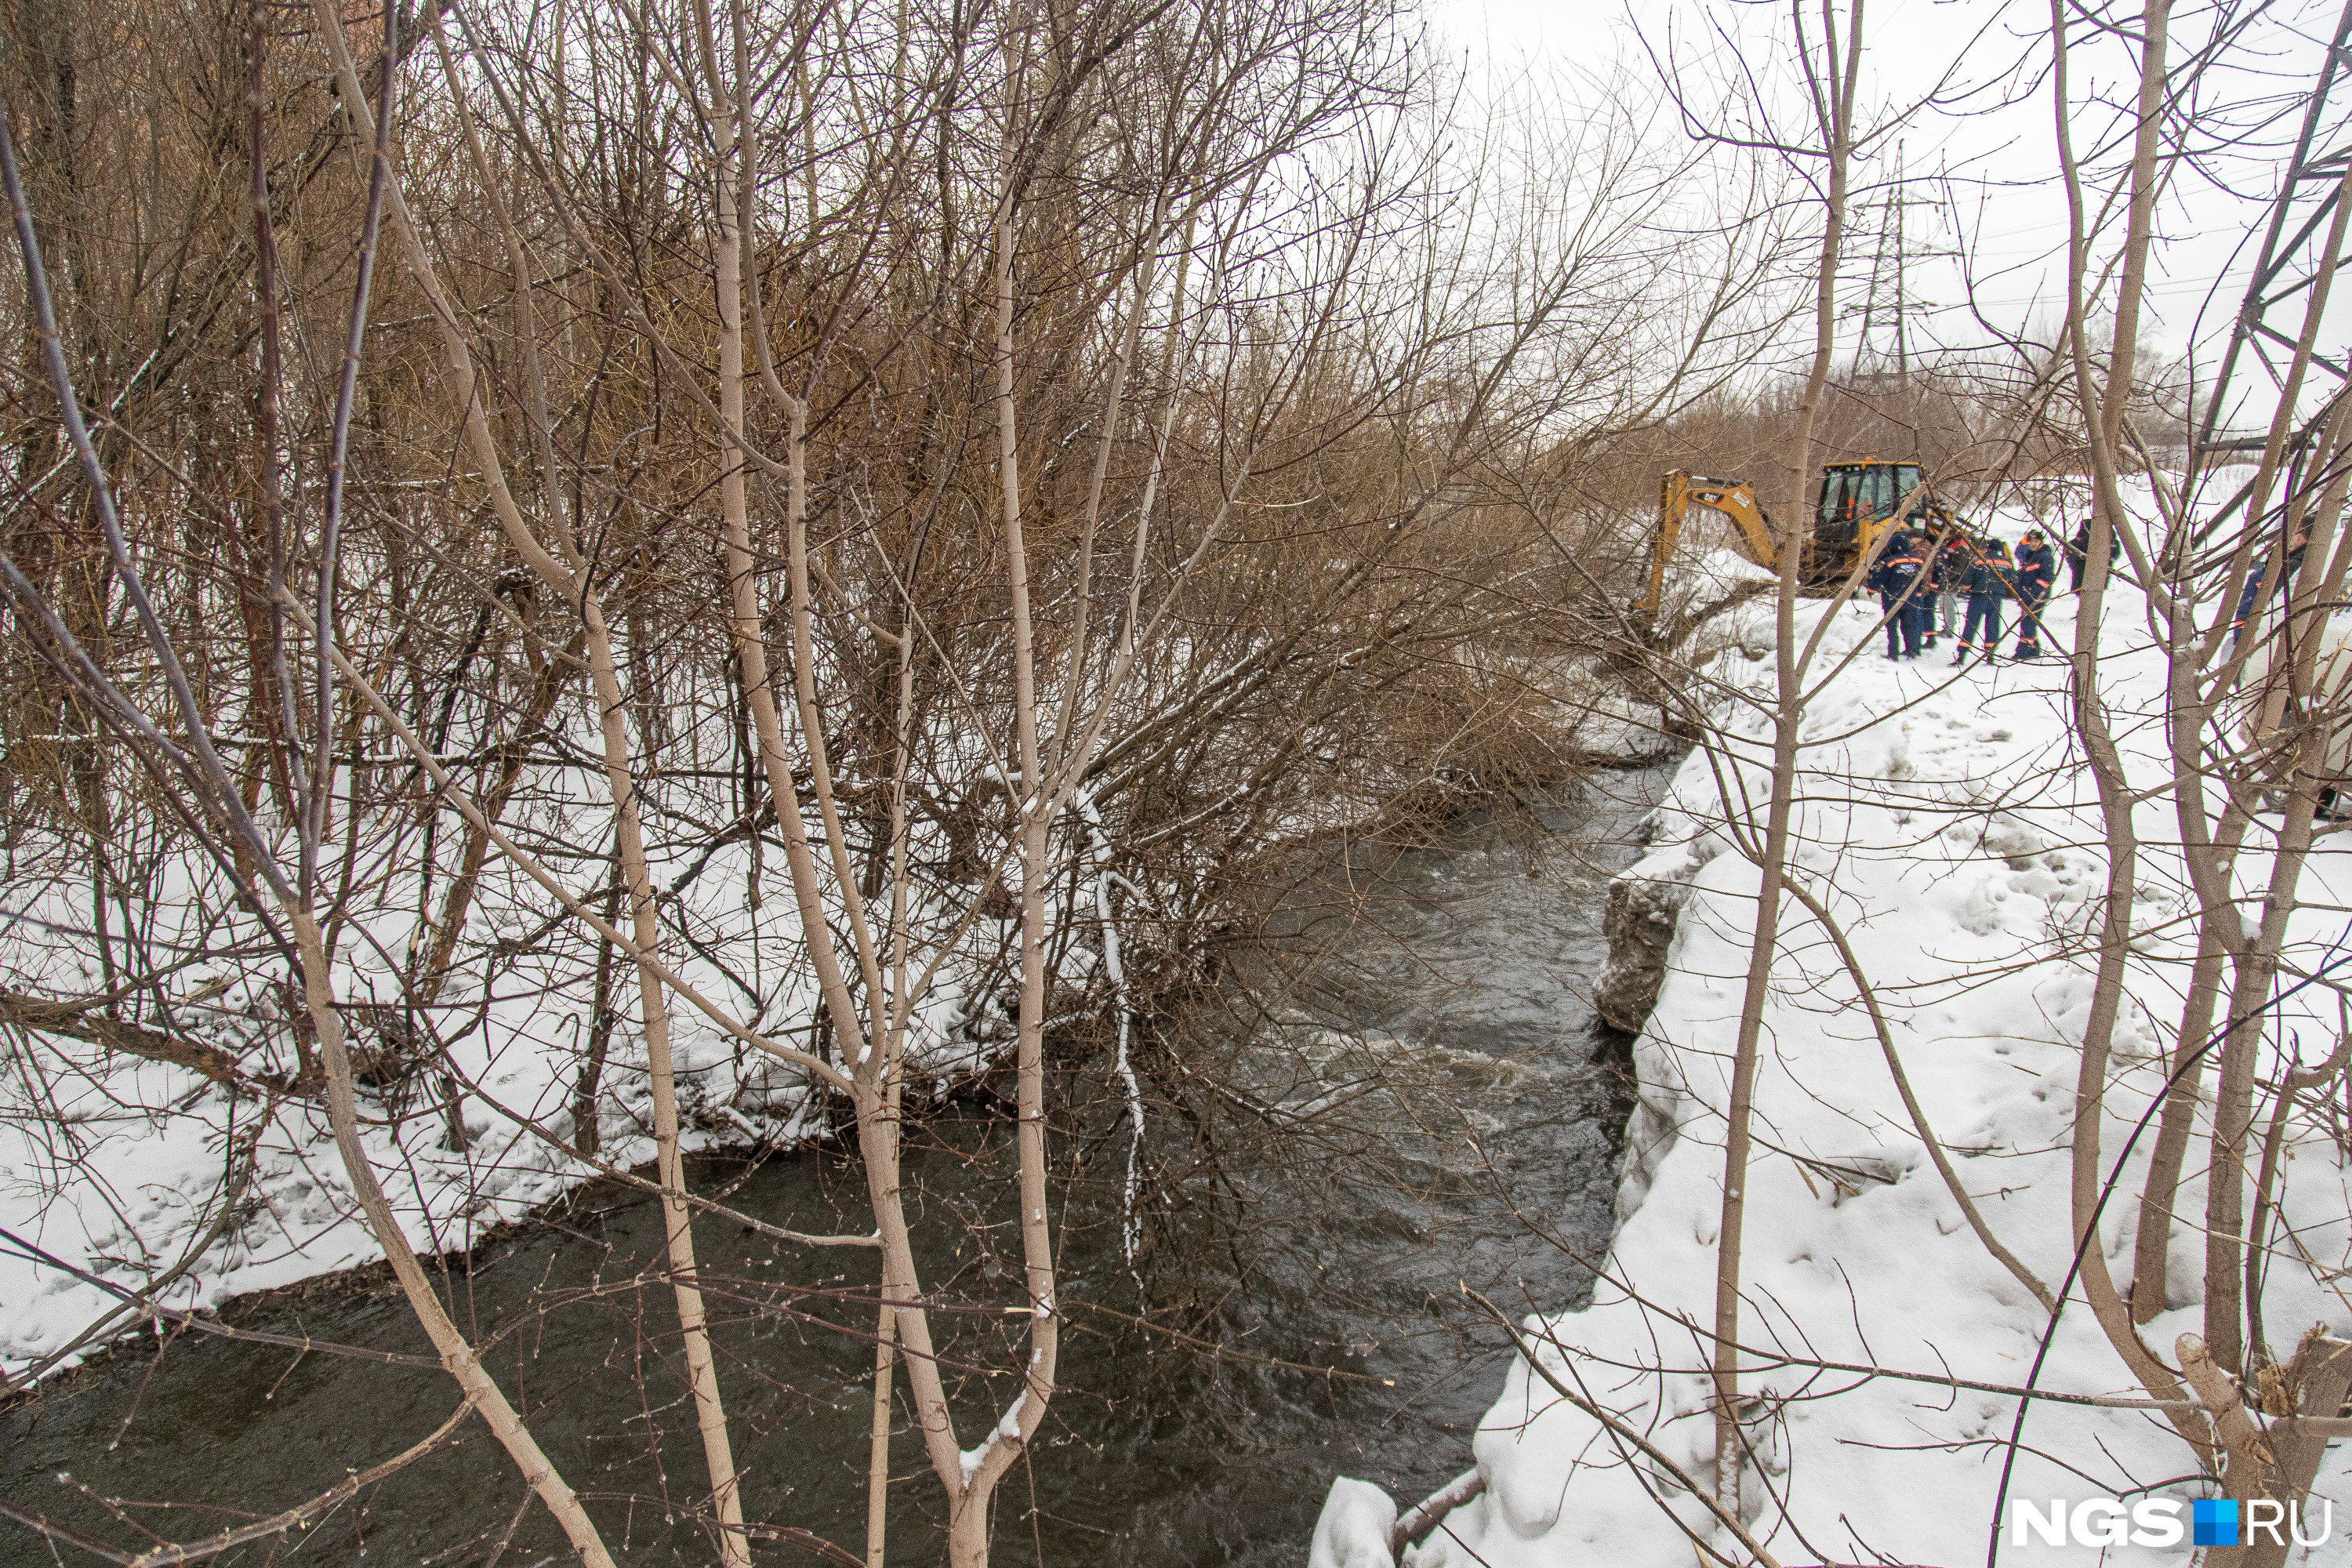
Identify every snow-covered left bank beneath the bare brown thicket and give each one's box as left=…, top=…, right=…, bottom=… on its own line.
left=0, top=769, right=1004, bottom=1375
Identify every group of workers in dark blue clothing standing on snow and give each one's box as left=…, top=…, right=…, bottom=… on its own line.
left=1870, top=527, right=2089, bottom=666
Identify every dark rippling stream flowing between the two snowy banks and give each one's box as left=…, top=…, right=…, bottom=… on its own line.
left=0, top=769, right=1665, bottom=1568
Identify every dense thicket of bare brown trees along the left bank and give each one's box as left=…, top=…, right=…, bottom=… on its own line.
left=0, top=0, right=1797, bottom=1563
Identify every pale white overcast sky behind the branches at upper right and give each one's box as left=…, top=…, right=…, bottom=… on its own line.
left=1425, top=0, right=2352, bottom=425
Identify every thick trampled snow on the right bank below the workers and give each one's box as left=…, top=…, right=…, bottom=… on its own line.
left=1312, top=524, right=2352, bottom=1568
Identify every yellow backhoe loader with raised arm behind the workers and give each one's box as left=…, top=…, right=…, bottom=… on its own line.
left=1635, top=459, right=1959, bottom=628
